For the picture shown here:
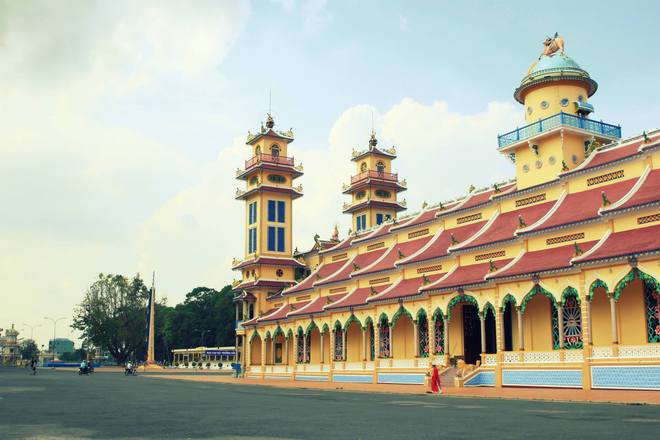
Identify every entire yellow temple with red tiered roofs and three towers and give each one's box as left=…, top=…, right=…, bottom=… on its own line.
left=233, top=37, right=660, bottom=389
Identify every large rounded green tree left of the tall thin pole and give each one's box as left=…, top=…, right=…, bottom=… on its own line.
left=72, top=274, right=149, bottom=363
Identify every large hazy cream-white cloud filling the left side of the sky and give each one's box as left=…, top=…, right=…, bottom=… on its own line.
left=0, top=0, right=250, bottom=341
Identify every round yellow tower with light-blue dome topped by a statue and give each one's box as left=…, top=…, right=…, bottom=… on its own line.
left=498, top=34, right=621, bottom=189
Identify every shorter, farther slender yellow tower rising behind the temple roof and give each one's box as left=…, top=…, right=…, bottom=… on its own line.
left=343, top=132, right=406, bottom=232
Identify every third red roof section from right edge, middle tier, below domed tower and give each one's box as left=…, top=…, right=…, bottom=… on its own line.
left=452, top=201, right=555, bottom=251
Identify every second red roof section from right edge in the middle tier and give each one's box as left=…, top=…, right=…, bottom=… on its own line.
left=520, top=179, right=637, bottom=234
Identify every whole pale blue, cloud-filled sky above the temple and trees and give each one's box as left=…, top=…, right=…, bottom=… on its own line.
left=0, top=0, right=660, bottom=345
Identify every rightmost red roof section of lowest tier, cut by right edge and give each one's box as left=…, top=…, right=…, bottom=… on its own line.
left=573, top=225, right=660, bottom=264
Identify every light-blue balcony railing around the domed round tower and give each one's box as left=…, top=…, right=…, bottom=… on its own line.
left=497, top=112, right=621, bottom=148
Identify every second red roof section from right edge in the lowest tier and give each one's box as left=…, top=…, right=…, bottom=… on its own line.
left=488, top=240, right=596, bottom=279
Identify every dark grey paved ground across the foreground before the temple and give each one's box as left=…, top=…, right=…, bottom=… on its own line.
left=0, top=368, right=660, bottom=439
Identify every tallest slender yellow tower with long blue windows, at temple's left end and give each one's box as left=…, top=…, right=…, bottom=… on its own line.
left=232, top=114, right=303, bottom=321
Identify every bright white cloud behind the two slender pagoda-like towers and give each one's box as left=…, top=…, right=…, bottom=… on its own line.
left=140, top=98, right=521, bottom=298
